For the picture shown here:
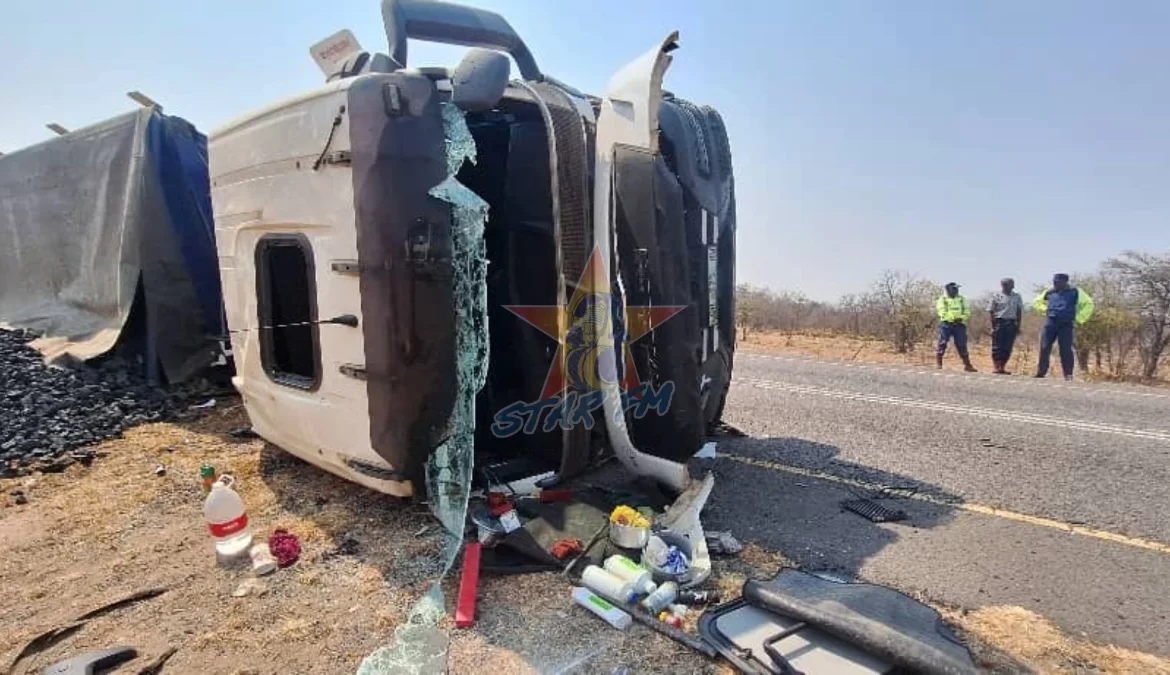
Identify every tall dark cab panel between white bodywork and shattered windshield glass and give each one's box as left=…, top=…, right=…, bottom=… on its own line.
left=349, top=71, right=457, bottom=489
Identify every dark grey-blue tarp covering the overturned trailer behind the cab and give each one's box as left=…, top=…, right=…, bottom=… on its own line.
left=0, top=109, right=225, bottom=381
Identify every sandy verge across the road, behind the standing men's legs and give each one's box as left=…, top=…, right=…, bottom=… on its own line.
left=738, top=331, right=1170, bottom=387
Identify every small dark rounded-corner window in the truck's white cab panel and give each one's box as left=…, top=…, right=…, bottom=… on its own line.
left=256, top=234, right=321, bottom=390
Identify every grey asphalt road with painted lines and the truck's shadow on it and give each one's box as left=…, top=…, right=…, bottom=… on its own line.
left=704, top=352, right=1170, bottom=655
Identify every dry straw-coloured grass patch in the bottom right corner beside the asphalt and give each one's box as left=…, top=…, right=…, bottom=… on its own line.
left=944, top=607, right=1170, bottom=675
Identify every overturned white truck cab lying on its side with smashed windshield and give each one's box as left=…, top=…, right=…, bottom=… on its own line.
left=209, top=0, right=735, bottom=510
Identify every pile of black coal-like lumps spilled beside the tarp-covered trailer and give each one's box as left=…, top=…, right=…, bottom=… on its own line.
left=0, top=330, right=217, bottom=478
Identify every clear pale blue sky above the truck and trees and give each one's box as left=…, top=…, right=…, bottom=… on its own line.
left=0, top=0, right=1170, bottom=301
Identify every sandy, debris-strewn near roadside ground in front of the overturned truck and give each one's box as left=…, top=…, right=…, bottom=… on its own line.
left=0, top=401, right=1170, bottom=675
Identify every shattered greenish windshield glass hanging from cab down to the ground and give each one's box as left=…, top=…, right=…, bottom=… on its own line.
left=358, top=102, right=488, bottom=675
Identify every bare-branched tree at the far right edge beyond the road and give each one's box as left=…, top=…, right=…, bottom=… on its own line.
left=1104, top=250, right=1170, bottom=379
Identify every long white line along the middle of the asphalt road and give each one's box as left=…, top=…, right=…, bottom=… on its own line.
left=732, top=377, right=1170, bottom=443
